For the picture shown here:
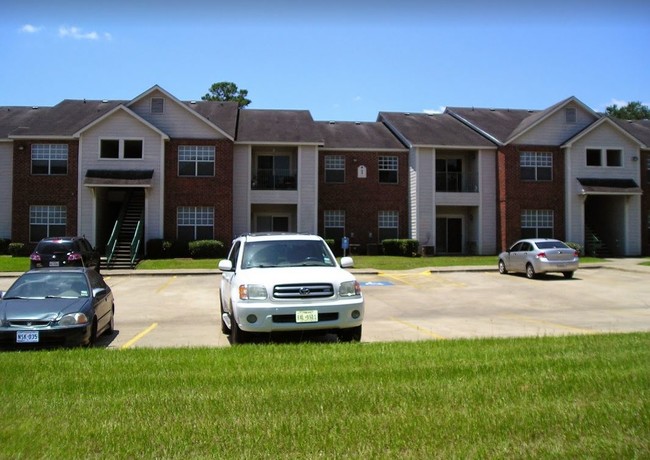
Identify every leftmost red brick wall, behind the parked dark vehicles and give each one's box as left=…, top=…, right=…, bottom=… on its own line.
left=11, top=139, right=79, bottom=249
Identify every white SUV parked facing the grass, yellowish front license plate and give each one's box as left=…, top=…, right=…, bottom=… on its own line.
left=219, top=233, right=364, bottom=344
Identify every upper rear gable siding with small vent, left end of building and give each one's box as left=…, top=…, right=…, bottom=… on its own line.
left=129, top=91, right=224, bottom=139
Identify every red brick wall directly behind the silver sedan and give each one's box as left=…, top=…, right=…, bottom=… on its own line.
left=497, top=145, right=566, bottom=250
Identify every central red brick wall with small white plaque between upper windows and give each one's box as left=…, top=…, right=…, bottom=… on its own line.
left=318, top=151, right=408, bottom=251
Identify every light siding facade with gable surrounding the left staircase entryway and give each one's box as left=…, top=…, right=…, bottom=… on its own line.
left=78, top=111, right=164, bottom=245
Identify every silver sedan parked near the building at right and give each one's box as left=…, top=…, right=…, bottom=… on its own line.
left=499, top=238, right=579, bottom=279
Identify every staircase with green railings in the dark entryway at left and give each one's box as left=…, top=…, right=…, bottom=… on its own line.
left=106, top=189, right=144, bottom=269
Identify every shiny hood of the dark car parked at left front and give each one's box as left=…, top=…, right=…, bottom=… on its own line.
left=0, top=298, right=91, bottom=321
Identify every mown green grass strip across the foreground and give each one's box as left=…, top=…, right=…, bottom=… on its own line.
left=0, top=333, right=650, bottom=459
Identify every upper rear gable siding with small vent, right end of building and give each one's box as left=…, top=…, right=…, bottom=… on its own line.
left=516, top=104, right=596, bottom=145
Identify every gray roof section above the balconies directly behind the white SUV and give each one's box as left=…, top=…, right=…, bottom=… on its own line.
left=237, top=109, right=323, bottom=144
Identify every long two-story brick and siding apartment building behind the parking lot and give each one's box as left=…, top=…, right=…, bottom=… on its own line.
left=0, top=85, right=650, bottom=256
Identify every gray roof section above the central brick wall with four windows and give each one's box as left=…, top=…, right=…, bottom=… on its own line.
left=316, top=121, right=406, bottom=150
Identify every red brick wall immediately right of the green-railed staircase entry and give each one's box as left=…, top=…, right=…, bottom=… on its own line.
left=164, top=139, right=233, bottom=245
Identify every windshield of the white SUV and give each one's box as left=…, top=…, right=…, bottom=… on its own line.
left=242, top=240, right=335, bottom=269
